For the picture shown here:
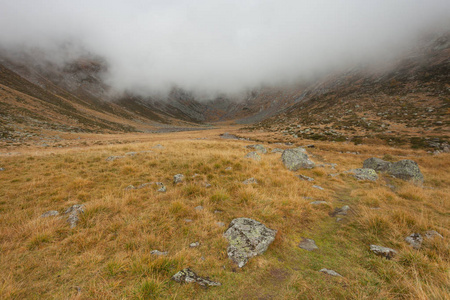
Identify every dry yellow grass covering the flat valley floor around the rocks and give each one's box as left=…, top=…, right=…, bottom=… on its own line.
left=0, top=130, right=450, bottom=299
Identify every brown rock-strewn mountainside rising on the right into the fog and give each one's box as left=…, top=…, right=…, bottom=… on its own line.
left=248, top=35, right=450, bottom=149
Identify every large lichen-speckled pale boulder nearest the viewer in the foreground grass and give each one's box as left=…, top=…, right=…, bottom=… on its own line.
left=224, top=218, right=277, bottom=268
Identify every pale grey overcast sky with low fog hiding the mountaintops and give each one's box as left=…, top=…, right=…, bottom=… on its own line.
left=0, top=0, right=450, bottom=96
